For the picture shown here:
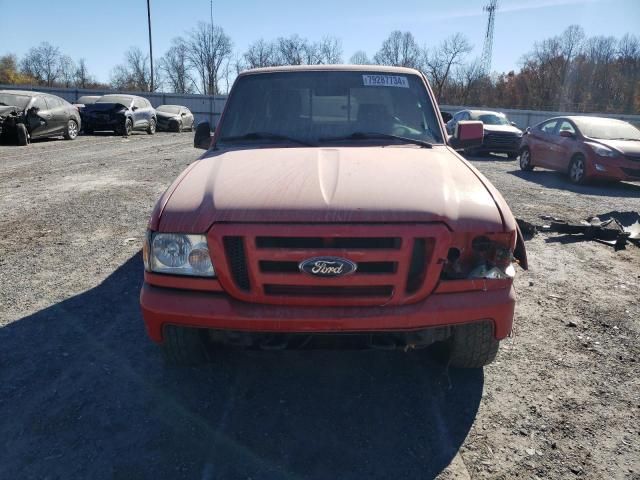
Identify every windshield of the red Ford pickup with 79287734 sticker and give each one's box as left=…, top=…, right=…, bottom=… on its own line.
left=218, top=71, right=442, bottom=145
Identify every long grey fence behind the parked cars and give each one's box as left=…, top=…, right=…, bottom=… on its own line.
left=0, top=85, right=640, bottom=129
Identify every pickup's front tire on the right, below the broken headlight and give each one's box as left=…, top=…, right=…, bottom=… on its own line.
left=449, top=322, right=500, bottom=368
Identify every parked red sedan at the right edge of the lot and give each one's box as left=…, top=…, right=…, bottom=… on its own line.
left=520, top=116, right=640, bottom=183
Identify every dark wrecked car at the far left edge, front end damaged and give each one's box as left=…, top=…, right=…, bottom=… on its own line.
left=0, top=90, right=80, bottom=145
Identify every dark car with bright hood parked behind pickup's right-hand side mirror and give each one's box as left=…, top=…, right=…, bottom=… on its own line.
left=447, top=110, right=522, bottom=158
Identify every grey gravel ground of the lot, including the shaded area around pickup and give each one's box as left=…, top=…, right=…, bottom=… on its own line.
left=0, top=134, right=640, bottom=480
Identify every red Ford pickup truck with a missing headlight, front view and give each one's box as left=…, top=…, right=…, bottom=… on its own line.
left=140, top=66, right=527, bottom=367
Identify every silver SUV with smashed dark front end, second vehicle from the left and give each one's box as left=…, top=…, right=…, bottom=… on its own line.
left=82, top=94, right=158, bottom=136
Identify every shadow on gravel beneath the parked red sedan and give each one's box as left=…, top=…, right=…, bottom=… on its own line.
left=508, top=170, right=640, bottom=198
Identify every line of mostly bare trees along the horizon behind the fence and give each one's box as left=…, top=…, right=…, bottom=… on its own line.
left=0, top=22, right=640, bottom=113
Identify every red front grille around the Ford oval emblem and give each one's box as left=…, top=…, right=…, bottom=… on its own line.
left=209, top=224, right=449, bottom=306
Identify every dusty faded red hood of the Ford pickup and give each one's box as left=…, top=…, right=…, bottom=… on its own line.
left=156, top=145, right=503, bottom=233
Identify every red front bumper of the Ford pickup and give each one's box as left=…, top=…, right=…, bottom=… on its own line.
left=140, top=282, right=515, bottom=342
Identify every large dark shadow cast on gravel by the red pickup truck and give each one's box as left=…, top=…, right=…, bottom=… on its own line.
left=0, top=254, right=483, bottom=479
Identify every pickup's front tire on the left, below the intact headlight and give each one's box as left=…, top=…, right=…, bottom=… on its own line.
left=162, top=325, right=209, bottom=367
